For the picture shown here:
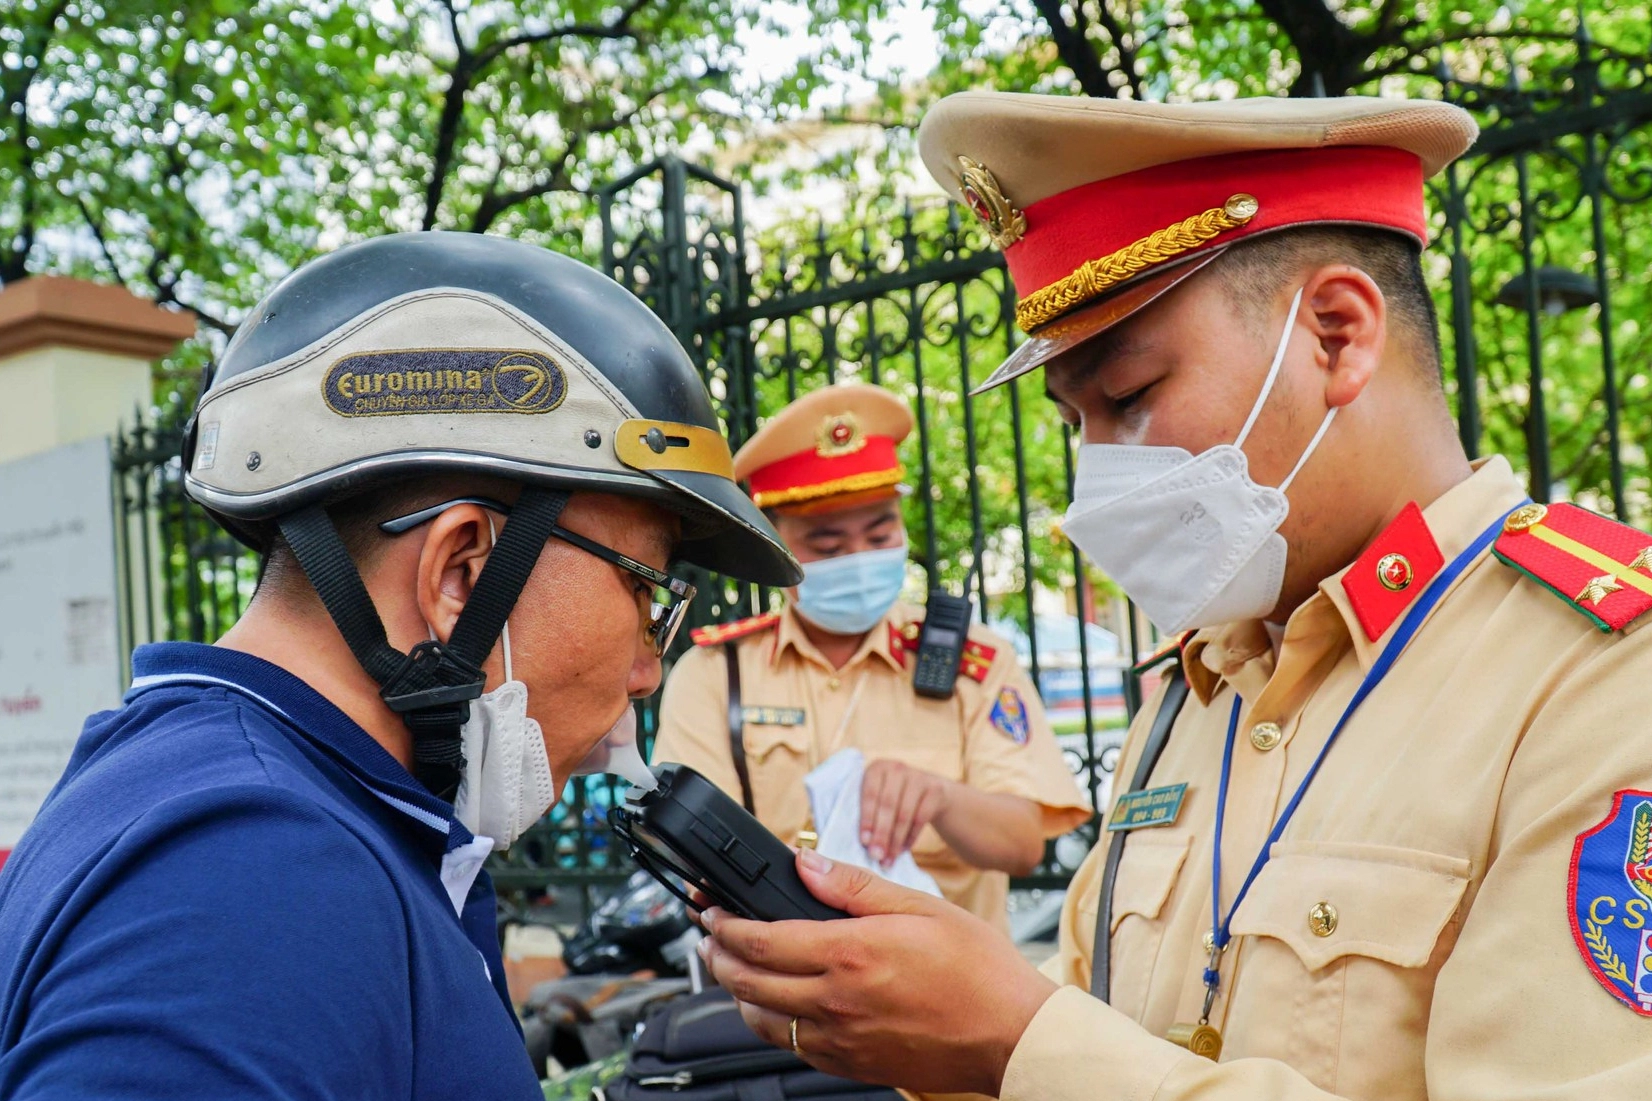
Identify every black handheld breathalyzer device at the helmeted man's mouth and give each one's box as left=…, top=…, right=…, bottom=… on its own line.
left=608, top=764, right=847, bottom=921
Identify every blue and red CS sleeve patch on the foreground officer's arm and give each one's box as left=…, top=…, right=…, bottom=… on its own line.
left=1566, top=790, right=1652, bottom=1017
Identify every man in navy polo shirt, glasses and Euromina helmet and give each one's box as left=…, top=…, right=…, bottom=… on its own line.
left=0, top=233, right=800, bottom=1101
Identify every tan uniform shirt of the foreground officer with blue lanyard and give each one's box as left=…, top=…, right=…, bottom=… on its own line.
left=1003, top=458, right=1652, bottom=1101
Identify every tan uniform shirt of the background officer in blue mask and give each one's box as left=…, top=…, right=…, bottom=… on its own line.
left=653, top=603, right=1090, bottom=929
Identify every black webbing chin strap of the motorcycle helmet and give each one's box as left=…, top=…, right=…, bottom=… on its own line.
left=279, top=488, right=568, bottom=802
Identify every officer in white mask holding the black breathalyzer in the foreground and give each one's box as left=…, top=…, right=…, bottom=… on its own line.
left=705, top=93, right=1652, bottom=1101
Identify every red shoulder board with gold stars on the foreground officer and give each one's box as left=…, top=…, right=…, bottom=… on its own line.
left=1492, top=504, right=1652, bottom=632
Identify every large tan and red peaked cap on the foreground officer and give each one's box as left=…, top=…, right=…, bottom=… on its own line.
left=919, top=93, right=1479, bottom=392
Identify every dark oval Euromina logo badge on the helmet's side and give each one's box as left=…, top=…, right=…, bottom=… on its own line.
left=320, top=347, right=568, bottom=417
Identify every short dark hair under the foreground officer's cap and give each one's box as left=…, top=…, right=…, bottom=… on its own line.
left=1211, top=226, right=1441, bottom=384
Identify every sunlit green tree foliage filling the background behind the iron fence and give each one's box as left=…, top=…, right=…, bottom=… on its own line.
left=0, top=0, right=1652, bottom=644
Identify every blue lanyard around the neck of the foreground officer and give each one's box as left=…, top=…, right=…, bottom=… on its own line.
left=1204, top=503, right=1525, bottom=991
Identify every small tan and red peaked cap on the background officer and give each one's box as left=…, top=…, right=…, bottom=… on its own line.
left=733, top=382, right=912, bottom=511
